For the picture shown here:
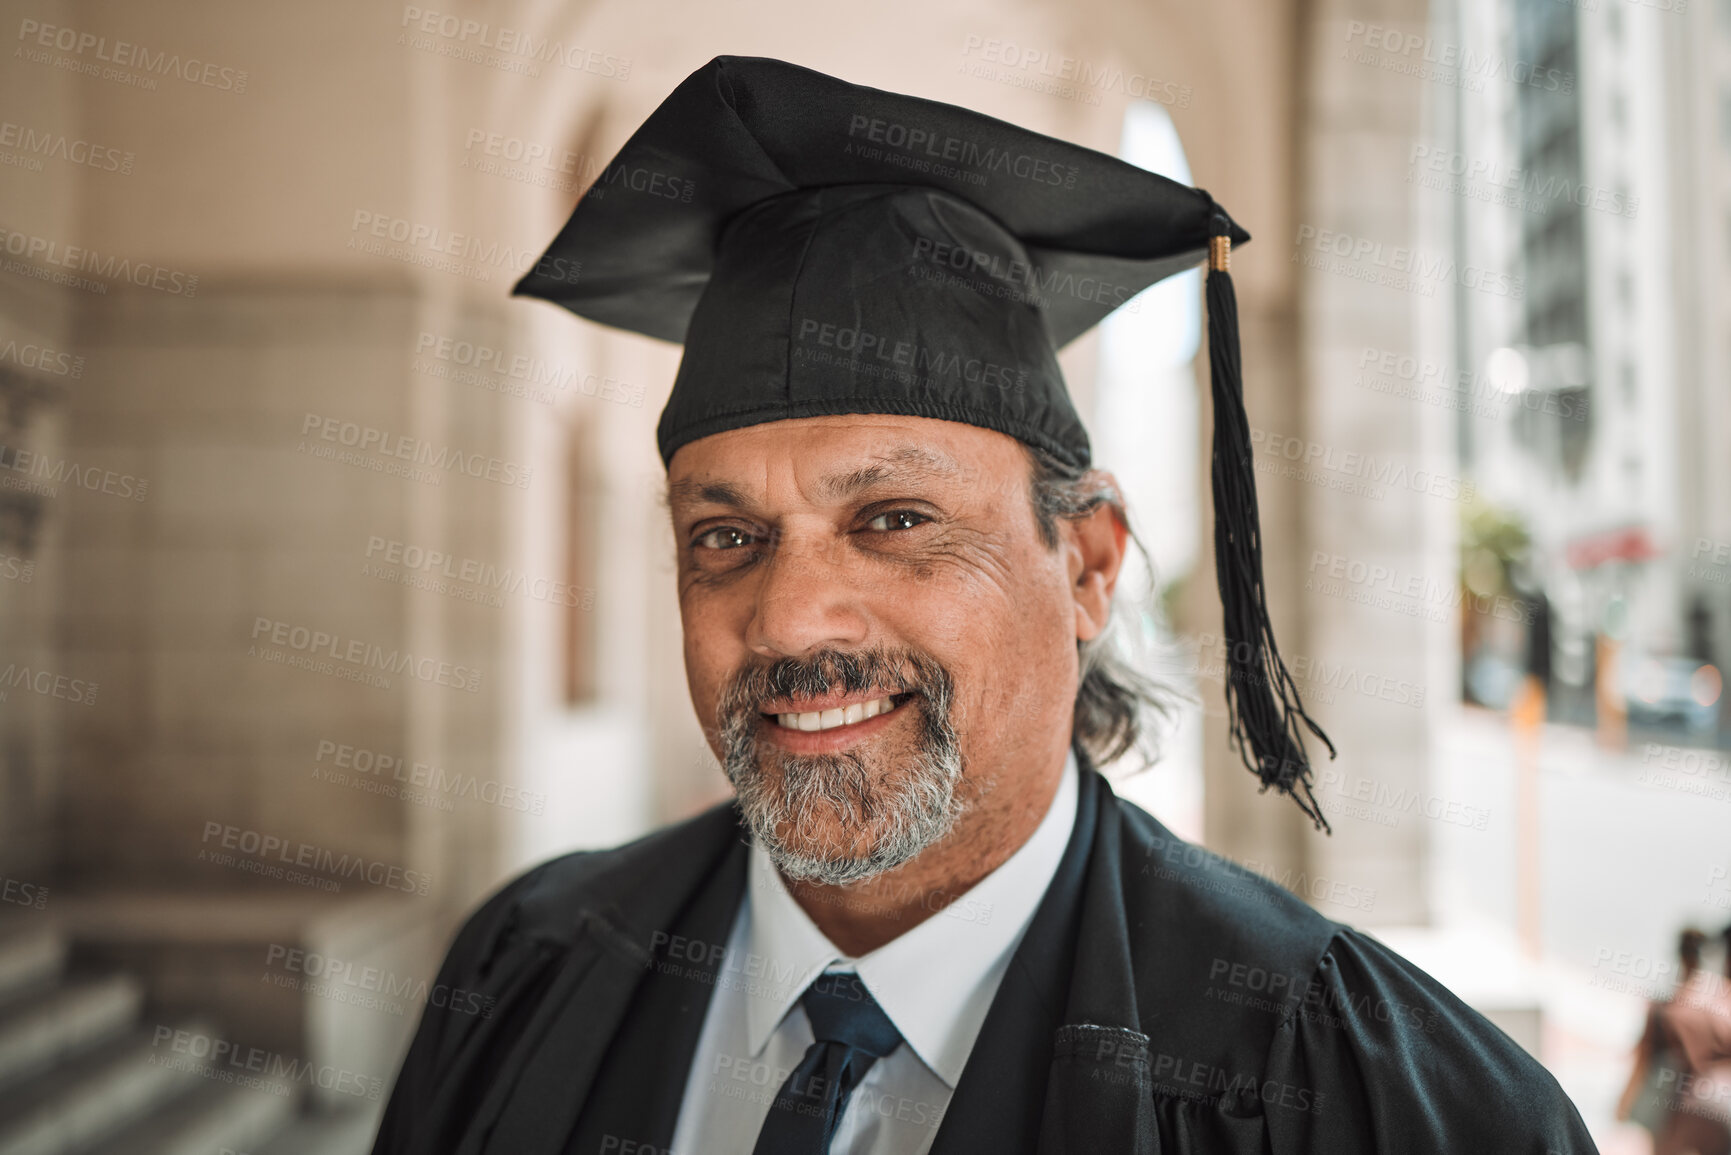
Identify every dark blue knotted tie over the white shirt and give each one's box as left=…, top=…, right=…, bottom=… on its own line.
left=751, top=971, right=902, bottom=1155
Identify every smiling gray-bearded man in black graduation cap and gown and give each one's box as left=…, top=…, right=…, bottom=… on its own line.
left=376, top=57, right=1593, bottom=1155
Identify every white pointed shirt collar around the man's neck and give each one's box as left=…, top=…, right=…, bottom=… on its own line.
left=744, top=752, right=1078, bottom=1089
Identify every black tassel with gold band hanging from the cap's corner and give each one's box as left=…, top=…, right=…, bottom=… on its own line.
left=1208, top=225, right=1335, bottom=833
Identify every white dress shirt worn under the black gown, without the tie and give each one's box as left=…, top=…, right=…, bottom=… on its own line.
left=672, top=753, right=1078, bottom=1155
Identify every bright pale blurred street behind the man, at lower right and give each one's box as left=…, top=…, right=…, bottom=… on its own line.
left=1419, top=708, right=1731, bottom=1153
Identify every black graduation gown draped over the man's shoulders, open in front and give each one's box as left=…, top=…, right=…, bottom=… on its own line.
left=374, top=750, right=1596, bottom=1155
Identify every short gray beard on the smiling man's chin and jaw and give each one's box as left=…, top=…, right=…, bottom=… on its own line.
left=720, top=651, right=966, bottom=887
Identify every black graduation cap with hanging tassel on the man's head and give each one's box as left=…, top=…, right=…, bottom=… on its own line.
left=514, top=55, right=1335, bottom=828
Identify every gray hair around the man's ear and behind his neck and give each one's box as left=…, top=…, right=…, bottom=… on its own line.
left=1023, top=443, right=1175, bottom=765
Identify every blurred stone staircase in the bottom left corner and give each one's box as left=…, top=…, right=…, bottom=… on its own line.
left=0, top=925, right=377, bottom=1155
